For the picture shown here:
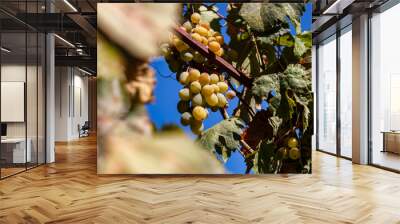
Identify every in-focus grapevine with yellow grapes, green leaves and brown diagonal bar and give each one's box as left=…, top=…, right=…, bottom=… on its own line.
left=160, top=3, right=313, bottom=173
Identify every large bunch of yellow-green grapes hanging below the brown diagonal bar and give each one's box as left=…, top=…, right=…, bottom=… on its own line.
left=177, top=68, right=236, bottom=134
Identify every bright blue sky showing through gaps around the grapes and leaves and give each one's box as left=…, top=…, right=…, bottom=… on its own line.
left=147, top=3, right=312, bottom=174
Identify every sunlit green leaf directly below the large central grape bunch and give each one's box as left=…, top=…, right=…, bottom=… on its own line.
left=200, top=117, right=245, bottom=161
